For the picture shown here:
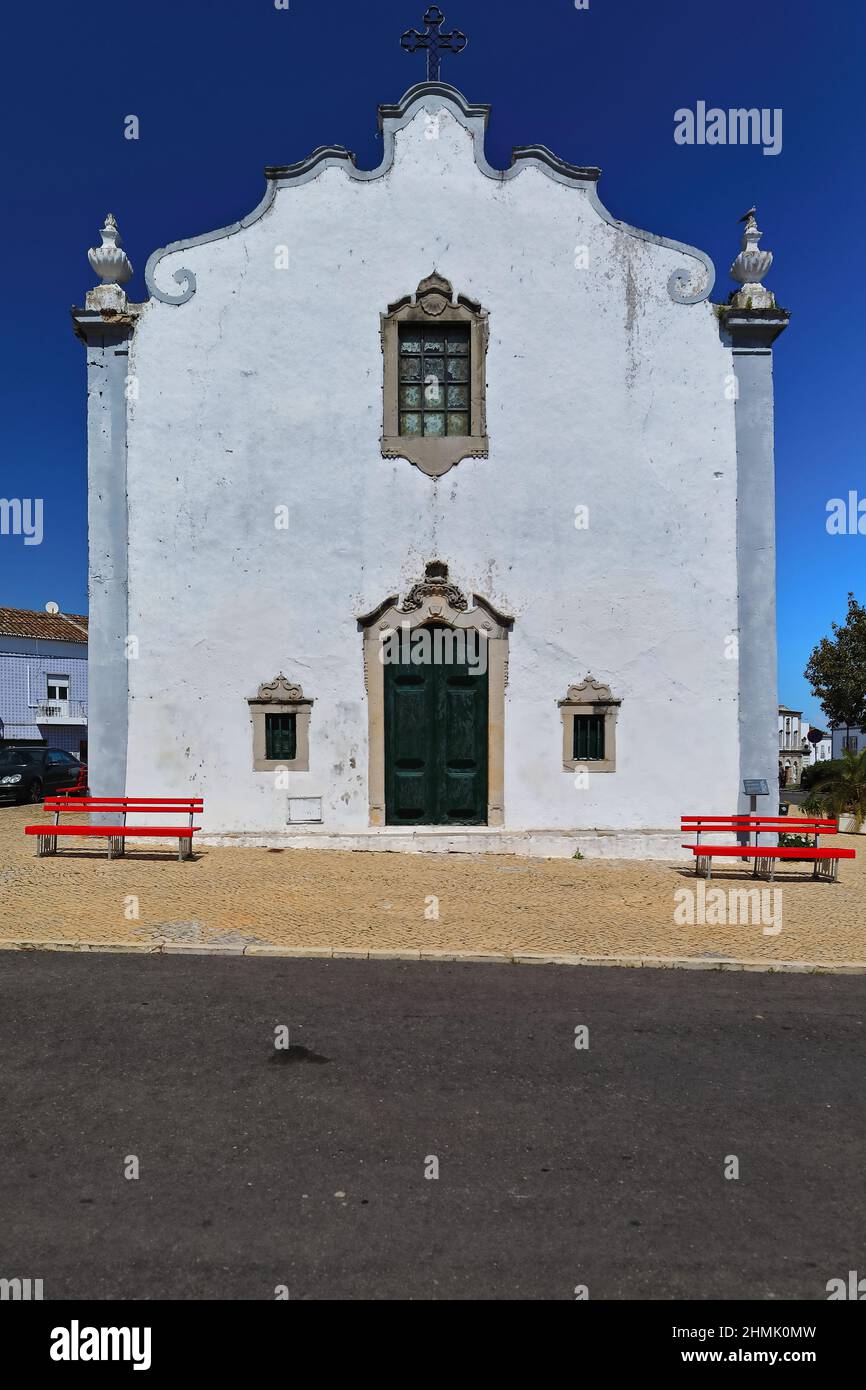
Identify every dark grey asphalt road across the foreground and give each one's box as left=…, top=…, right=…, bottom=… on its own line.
left=0, top=952, right=866, bottom=1300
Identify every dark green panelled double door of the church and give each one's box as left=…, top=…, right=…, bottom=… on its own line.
left=385, top=631, right=488, bottom=826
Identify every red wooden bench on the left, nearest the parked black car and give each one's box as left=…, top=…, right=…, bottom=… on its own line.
left=24, top=795, right=204, bottom=859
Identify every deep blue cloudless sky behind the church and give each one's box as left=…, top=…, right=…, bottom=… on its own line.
left=0, top=0, right=866, bottom=721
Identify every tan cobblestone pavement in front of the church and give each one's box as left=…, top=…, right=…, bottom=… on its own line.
left=0, top=806, right=866, bottom=965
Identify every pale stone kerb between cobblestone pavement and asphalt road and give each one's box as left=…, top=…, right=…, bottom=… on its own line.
left=0, top=937, right=866, bottom=974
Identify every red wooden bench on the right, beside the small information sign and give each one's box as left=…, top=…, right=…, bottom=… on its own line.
left=681, top=815, right=856, bottom=883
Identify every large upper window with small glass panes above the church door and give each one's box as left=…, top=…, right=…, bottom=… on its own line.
left=399, top=324, right=471, bottom=436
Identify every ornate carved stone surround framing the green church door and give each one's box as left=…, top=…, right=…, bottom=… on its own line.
left=357, top=560, right=514, bottom=827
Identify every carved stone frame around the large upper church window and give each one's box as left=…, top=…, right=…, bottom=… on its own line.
left=381, top=272, right=489, bottom=478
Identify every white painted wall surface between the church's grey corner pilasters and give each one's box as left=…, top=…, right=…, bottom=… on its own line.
left=128, top=100, right=740, bottom=833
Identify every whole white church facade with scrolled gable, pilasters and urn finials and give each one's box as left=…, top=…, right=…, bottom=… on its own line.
left=74, top=82, right=787, bottom=858
